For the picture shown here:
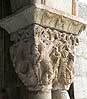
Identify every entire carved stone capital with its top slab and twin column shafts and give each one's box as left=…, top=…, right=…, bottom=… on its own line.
left=0, top=1, right=85, bottom=99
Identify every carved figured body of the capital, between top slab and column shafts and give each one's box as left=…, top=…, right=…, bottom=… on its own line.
left=10, top=24, right=78, bottom=90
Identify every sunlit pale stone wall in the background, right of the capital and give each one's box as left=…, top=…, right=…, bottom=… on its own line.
left=74, top=3, right=87, bottom=99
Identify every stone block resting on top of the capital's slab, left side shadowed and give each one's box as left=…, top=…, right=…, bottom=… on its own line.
left=10, top=0, right=72, bottom=14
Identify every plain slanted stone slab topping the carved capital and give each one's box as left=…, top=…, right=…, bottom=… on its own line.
left=0, top=5, right=86, bottom=35
